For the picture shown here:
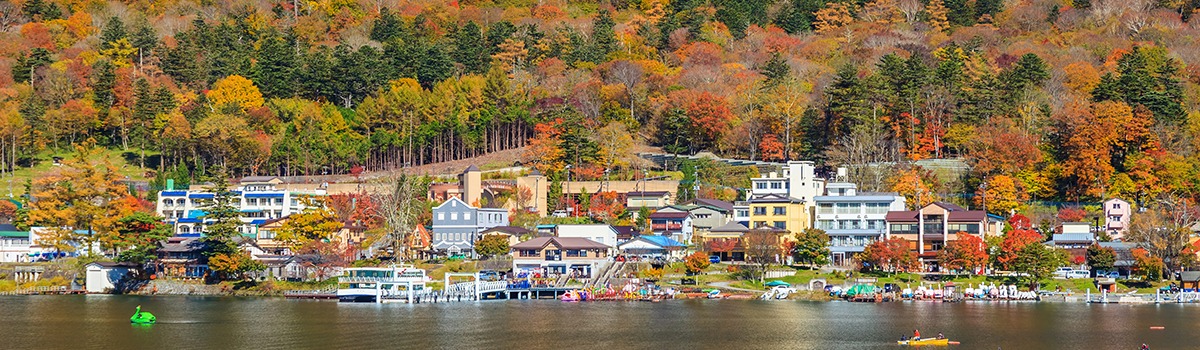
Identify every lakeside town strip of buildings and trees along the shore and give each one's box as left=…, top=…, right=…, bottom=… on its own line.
left=0, top=153, right=1200, bottom=303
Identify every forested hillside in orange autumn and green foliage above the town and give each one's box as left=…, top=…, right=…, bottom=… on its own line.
left=0, top=0, right=1200, bottom=207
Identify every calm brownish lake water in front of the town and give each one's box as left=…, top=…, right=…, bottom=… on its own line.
left=0, top=296, right=1200, bottom=350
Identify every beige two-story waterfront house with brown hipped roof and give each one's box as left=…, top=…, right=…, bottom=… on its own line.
left=510, top=237, right=612, bottom=278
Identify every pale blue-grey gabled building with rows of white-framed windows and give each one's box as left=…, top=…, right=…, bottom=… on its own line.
left=431, top=197, right=509, bottom=257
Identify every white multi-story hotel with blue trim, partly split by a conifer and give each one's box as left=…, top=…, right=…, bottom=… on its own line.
left=155, top=176, right=326, bottom=236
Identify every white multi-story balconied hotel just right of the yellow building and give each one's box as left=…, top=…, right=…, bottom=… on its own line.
left=812, top=182, right=905, bottom=266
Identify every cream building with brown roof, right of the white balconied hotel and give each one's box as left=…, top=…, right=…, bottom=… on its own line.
left=884, top=201, right=991, bottom=271
